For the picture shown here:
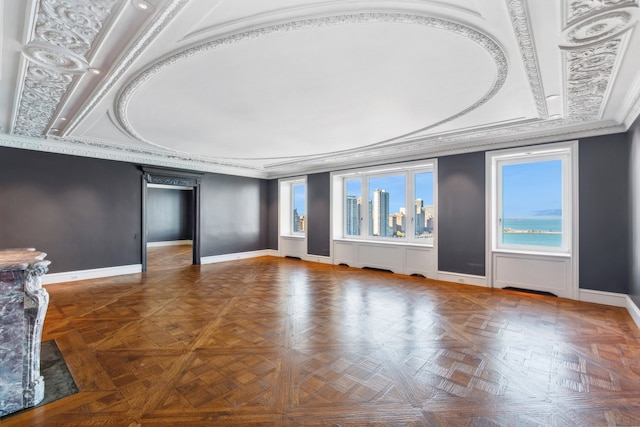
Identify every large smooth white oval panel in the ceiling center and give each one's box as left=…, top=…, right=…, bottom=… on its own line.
left=118, top=13, right=500, bottom=158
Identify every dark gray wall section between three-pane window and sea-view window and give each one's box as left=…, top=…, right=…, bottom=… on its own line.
left=436, top=152, right=485, bottom=276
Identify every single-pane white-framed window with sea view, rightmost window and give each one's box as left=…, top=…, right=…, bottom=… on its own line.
left=493, top=148, right=571, bottom=252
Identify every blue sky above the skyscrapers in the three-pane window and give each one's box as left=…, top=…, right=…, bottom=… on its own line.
left=347, top=172, right=433, bottom=213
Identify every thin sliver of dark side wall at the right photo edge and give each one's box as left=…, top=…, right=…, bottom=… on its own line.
left=629, top=118, right=640, bottom=307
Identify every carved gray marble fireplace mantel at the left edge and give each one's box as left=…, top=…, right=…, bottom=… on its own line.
left=0, top=249, right=51, bottom=416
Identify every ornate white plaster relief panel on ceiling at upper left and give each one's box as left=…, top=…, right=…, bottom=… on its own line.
left=12, top=0, right=117, bottom=138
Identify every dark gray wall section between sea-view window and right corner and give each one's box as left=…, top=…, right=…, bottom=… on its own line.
left=579, top=133, right=631, bottom=293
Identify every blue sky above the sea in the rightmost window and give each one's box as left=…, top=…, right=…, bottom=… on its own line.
left=502, top=160, right=562, bottom=218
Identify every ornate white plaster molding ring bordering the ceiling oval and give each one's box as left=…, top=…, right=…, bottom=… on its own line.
left=115, top=12, right=508, bottom=158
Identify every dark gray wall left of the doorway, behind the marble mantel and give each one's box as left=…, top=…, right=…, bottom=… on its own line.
left=0, top=147, right=142, bottom=273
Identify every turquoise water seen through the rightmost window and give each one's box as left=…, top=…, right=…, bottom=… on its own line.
left=502, top=218, right=562, bottom=247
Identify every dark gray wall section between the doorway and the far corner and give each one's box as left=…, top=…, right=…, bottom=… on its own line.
left=201, top=174, right=269, bottom=257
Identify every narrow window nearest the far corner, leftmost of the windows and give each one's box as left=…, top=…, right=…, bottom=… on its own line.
left=280, top=178, right=308, bottom=237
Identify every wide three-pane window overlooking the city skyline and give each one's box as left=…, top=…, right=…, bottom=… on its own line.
left=333, top=161, right=435, bottom=244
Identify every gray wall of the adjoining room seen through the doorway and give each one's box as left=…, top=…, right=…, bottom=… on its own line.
left=147, top=188, right=193, bottom=242
